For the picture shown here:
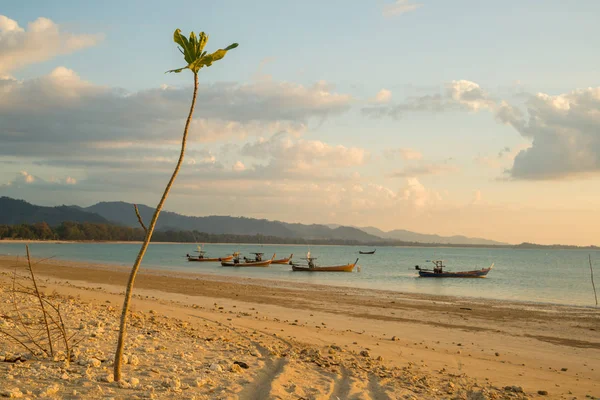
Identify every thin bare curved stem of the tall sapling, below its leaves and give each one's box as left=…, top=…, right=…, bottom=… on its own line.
left=114, top=73, right=198, bottom=382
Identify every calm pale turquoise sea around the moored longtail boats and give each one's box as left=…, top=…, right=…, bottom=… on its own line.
left=0, top=243, right=600, bottom=306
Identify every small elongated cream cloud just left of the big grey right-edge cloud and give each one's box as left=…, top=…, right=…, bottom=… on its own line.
left=362, top=80, right=497, bottom=118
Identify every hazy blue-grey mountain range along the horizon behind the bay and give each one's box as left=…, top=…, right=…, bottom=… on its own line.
left=0, top=197, right=506, bottom=245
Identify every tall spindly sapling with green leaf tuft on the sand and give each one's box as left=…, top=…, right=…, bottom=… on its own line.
left=114, top=29, right=238, bottom=381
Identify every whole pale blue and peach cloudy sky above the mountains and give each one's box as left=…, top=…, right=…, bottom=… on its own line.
left=0, top=0, right=600, bottom=245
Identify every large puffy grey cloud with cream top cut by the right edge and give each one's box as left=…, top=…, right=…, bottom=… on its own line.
left=496, top=87, right=600, bottom=180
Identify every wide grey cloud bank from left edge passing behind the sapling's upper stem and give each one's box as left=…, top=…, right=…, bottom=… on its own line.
left=0, top=67, right=352, bottom=167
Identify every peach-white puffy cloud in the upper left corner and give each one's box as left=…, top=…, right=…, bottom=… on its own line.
left=0, top=15, right=103, bottom=76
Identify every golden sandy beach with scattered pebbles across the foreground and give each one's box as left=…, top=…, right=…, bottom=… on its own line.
left=0, top=256, right=600, bottom=399
